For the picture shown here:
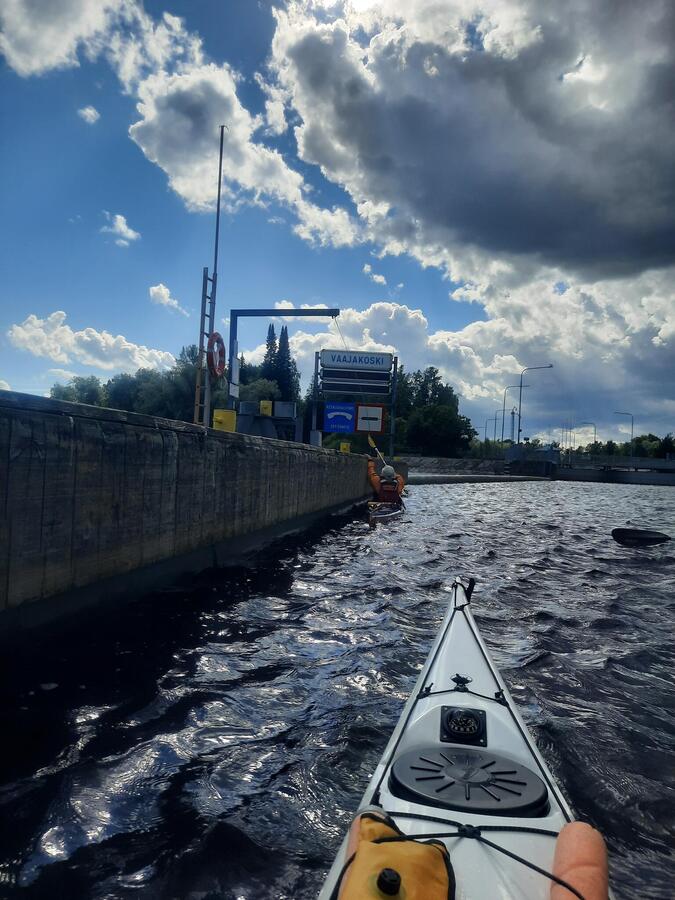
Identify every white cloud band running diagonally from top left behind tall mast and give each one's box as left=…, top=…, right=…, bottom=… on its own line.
left=0, top=0, right=362, bottom=246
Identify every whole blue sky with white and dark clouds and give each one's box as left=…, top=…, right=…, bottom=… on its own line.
left=0, top=0, right=675, bottom=439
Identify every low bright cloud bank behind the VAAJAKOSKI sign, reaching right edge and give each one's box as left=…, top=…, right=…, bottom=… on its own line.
left=245, top=269, right=675, bottom=440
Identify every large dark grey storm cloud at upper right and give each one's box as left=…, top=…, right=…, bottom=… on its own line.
left=274, top=2, right=675, bottom=276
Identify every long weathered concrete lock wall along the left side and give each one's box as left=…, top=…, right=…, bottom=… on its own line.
left=0, top=391, right=369, bottom=629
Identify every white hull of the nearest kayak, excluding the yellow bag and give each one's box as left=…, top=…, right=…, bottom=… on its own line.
left=319, top=582, right=573, bottom=900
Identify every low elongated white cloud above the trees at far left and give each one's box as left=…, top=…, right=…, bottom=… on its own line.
left=7, top=310, right=175, bottom=372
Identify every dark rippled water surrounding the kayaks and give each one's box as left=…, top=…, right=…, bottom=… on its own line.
left=0, top=483, right=675, bottom=900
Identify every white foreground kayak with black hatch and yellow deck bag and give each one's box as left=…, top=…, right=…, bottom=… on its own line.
left=319, top=581, right=608, bottom=900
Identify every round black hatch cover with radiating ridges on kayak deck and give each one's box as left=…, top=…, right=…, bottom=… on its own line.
left=389, top=746, right=548, bottom=817
